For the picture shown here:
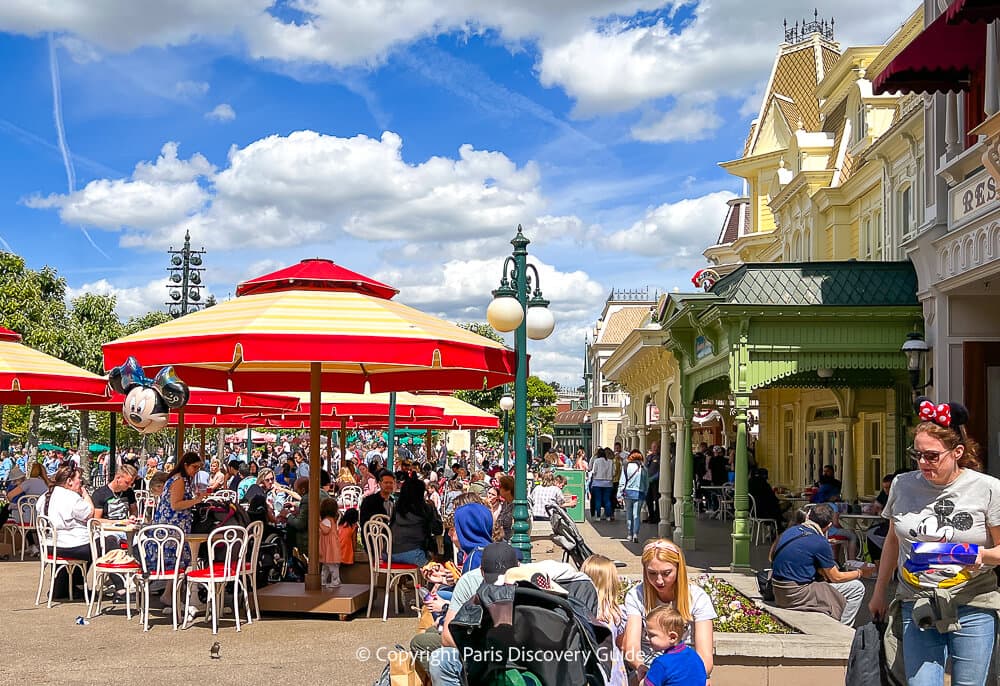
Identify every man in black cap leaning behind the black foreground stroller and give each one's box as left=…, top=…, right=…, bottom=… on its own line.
left=418, top=542, right=518, bottom=686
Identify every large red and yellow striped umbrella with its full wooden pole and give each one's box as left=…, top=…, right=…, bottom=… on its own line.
left=104, top=259, right=516, bottom=590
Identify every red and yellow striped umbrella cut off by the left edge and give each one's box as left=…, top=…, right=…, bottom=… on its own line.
left=0, top=327, right=110, bottom=405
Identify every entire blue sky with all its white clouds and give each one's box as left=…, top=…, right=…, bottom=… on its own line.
left=0, top=0, right=916, bottom=385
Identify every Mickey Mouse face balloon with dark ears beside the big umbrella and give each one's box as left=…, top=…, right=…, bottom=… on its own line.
left=108, top=357, right=191, bottom=434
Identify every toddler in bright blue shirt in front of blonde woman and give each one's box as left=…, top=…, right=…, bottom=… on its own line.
left=646, top=605, right=708, bottom=686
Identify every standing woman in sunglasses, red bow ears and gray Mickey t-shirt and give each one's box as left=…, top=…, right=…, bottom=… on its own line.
left=869, top=399, right=1000, bottom=686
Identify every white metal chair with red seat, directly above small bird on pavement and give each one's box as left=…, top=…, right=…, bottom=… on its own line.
left=183, top=526, right=252, bottom=634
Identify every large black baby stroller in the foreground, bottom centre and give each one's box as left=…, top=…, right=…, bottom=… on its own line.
left=449, top=583, right=612, bottom=686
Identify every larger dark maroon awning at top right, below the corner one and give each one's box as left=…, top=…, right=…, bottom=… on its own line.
left=872, top=13, right=986, bottom=95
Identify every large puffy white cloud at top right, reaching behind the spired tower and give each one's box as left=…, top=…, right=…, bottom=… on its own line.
left=538, top=0, right=913, bottom=115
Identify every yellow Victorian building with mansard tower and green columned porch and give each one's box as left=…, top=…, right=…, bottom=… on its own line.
left=605, top=12, right=923, bottom=567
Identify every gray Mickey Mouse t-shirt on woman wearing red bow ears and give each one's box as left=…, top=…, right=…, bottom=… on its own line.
left=882, top=469, right=1000, bottom=590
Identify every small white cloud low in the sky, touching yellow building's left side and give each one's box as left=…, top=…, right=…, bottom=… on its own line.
left=600, top=191, right=736, bottom=267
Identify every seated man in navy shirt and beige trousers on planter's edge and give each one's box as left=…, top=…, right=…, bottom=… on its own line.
left=771, top=504, right=873, bottom=626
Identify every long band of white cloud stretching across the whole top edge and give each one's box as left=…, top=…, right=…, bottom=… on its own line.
left=0, top=0, right=914, bottom=127
